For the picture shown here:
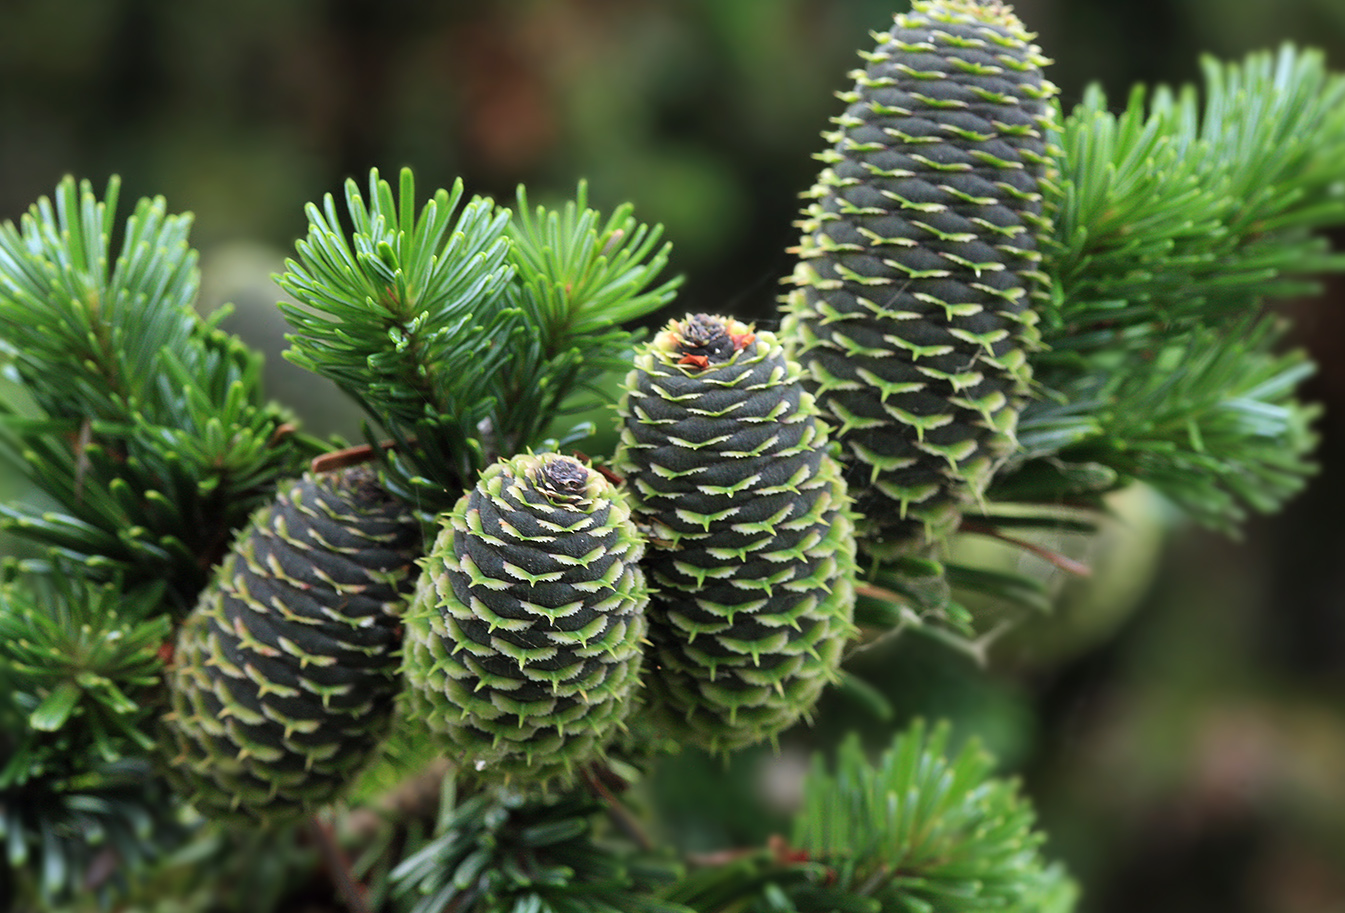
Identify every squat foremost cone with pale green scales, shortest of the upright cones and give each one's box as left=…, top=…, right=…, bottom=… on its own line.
left=405, top=453, right=648, bottom=788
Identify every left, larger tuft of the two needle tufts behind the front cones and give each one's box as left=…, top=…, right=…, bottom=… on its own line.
left=277, top=168, right=521, bottom=489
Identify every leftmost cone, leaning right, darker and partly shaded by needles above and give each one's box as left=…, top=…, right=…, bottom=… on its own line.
left=164, top=467, right=421, bottom=820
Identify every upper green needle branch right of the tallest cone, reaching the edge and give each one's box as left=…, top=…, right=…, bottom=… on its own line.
left=1034, top=44, right=1345, bottom=360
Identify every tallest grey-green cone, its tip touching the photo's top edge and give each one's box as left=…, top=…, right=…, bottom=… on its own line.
left=781, top=0, right=1054, bottom=554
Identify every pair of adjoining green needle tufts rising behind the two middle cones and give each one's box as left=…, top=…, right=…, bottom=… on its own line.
left=278, top=169, right=677, bottom=512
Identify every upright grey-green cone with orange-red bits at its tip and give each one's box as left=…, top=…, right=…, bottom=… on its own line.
left=613, top=315, right=855, bottom=752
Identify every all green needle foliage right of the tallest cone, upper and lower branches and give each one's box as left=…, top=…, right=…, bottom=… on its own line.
left=991, top=46, right=1345, bottom=531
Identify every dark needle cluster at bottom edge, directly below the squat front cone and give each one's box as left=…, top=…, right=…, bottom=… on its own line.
left=393, top=792, right=693, bottom=913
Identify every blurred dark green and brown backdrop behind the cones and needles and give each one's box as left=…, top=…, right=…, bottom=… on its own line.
left=0, top=0, right=1345, bottom=913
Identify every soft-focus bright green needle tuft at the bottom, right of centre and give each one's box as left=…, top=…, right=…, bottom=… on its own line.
left=660, top=723, right=1077, bottom=913
